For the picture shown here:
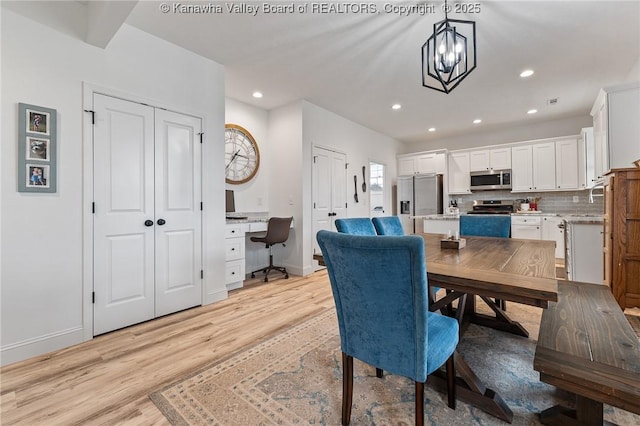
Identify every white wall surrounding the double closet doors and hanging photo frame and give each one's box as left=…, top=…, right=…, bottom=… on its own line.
left=0, top=8, right=227, bottom=364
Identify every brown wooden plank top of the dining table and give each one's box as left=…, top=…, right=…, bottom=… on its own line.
left=420, top=234, right=558, bottom=307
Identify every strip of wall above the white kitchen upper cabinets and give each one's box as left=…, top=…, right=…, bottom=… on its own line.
left=400, top=113, right=597, bottom=154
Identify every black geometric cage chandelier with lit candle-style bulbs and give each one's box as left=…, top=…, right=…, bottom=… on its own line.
left=422, top=0, right=476, bottom=93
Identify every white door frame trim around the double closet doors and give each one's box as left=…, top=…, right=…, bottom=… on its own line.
left=81, top=82, right=206, bottom=341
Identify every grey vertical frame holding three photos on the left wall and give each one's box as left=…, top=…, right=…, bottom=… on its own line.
left=17, top=103, right=58, bottom=193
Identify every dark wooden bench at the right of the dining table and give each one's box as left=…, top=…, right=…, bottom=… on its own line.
left=533, top=280, right=640, bottom=425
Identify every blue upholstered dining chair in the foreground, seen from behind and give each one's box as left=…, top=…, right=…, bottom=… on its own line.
left=316, top=231, right=458, bottom=425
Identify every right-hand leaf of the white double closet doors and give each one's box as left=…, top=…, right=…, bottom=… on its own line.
left=155, top=109, right=202, bottom=316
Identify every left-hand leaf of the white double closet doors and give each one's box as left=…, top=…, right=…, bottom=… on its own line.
left=93, top=94, right=155, bottom=334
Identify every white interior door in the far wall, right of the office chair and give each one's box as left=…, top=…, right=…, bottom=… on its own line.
left=311, top=147, right=347, bottom=262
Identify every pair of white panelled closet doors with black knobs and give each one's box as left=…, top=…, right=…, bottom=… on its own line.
left=93, top=93, right=202, bottom=335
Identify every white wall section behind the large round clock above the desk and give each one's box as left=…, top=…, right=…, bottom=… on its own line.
left=225, top=98, right=273, bottom=213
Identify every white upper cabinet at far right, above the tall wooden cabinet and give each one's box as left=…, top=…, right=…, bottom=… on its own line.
left=591, top=82, right=640, bottom=176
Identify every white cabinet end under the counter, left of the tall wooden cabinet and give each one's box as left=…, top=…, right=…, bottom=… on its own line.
left=565, top=221, right=604, bottom=284
